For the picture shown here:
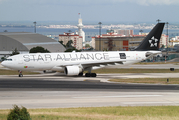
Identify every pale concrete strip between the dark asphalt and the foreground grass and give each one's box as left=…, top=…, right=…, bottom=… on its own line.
left=0, top=90, right=179, bottom=109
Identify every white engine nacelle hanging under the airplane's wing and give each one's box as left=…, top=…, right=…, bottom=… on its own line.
left=65, top=66, right=83, bottom=75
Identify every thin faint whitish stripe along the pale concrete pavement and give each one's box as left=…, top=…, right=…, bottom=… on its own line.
left=73, top=95, right=163, bottom=98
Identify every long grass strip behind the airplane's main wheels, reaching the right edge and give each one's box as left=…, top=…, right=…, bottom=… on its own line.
left=92, top=68, right=179, bottom=74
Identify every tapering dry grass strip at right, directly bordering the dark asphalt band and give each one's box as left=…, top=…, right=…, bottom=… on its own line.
left=109, top=78, right=179, bottom=84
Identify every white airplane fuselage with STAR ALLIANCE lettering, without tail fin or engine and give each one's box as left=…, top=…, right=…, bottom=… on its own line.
left=1, top=51, right=159, bottom=71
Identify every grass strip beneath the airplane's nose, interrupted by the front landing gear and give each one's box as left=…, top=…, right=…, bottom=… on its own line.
left=0, top=69, right=39, bottom=75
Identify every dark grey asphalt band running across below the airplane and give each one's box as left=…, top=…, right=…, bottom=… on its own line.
left=0, top=79, right=179, bottom=91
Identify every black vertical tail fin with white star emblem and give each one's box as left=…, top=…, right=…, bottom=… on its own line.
left=135, top=23, right=165, bottom=51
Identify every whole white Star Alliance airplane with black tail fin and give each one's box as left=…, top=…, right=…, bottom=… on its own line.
left=1, top=23, right=165, bottom=77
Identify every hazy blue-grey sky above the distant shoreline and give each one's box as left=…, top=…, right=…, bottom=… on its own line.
left=0, top=0, right=179, bottom=23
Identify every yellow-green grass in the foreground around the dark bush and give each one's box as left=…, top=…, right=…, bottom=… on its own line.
left=0, top=106, right=179, bottom=120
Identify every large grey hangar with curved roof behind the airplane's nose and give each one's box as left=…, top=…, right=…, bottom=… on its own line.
left=0, top=32, right=66, bottom=58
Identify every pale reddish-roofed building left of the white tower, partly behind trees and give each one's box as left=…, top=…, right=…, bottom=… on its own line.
left=59, top=32, right=83, bottom=50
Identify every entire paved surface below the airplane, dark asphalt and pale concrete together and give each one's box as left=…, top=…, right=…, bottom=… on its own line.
left=0, top=74, right=179, bottom=109
